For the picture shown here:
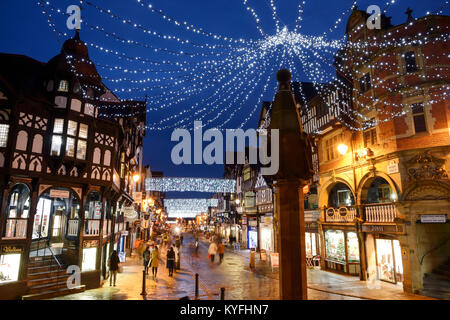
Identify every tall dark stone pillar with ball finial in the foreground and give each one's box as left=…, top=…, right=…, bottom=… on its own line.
left=263, top=69, right=314, bottom=300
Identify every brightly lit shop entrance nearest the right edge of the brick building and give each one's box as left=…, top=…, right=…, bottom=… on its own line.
left=375, top=239, right=403, bottom=283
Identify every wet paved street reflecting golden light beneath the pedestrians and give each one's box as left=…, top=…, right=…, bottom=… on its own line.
left=54, top=233, right=431, bottom=300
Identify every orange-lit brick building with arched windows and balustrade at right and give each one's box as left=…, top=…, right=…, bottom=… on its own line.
left=302, top=10, right=450, bottom=297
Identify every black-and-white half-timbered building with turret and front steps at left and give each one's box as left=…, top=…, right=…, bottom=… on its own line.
left=0, top=31, right=145, bottom=299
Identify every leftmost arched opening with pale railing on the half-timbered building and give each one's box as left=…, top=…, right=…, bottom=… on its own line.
left=3, top=183, right=30, bottom=238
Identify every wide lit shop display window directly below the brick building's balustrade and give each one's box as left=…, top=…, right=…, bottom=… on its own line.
left=324, top=229, right=360, bottom=275
